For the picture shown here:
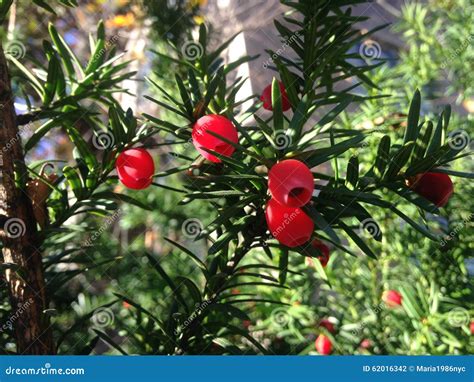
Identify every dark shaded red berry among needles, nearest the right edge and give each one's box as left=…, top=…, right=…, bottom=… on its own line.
left=409, top=172, right=454, bottom=207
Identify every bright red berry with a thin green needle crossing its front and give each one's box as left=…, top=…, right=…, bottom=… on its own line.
left=192, top=114, right=239, bottom=163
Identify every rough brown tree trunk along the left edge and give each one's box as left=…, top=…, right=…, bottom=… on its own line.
left=0, top=44, right=55, bottom=354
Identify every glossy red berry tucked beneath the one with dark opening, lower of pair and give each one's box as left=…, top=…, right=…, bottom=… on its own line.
left=265, top=199, right=314, bottom=248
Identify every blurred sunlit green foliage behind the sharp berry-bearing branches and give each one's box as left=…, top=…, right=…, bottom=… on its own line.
left=2, top=0, right=474, bottom=354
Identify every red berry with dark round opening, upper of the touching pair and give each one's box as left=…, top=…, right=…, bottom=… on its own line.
left=268, top=159, right=314, bottom=207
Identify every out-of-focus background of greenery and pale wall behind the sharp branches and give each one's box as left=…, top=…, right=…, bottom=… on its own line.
left=1, top=0, right=474, bottom=355
